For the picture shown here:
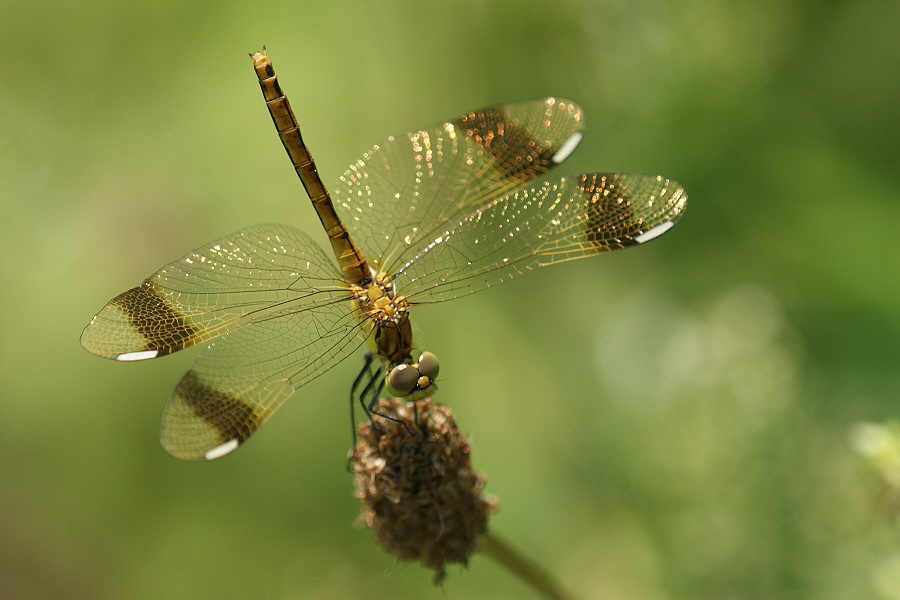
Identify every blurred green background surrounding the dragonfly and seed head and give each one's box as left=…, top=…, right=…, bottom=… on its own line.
left=0, top=0, right=900, bottom=600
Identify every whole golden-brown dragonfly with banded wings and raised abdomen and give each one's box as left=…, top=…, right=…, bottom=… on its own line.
left=81, top=49, right=687, bottom=460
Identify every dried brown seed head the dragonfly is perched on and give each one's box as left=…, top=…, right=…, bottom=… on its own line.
left=350, top=398, right=496, bottom=583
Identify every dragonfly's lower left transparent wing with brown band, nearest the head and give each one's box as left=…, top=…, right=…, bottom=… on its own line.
left=160, top=298, right=372, bottom=460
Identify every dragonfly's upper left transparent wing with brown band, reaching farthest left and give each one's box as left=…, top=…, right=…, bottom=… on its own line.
left=81, top=224, right=347, bottom=360
